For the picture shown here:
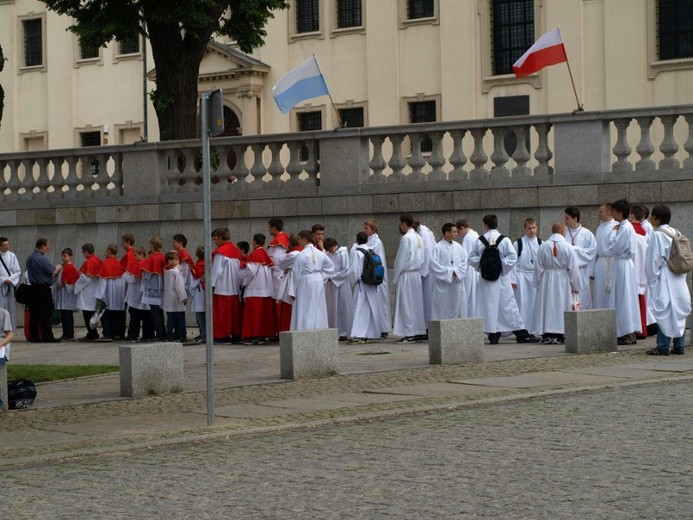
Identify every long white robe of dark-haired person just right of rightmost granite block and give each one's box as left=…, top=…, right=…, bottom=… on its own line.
left=609, top=220, right=642, bottom=337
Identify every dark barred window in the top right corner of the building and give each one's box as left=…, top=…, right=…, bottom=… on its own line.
left=657, top=0, right=693, bottom=60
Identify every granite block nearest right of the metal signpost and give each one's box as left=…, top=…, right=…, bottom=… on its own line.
left=279, top=329, right=339, bottom=379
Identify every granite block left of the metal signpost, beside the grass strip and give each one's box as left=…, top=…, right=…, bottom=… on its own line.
left=118, top=342, right=183, bottom=397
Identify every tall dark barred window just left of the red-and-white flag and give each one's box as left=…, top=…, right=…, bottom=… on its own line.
left=491, top=0, right=534, bottom=76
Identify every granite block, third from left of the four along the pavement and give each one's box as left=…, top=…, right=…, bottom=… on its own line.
left=428, top=318, right=484, bottom=365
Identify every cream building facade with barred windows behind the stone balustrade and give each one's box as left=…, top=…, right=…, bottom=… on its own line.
left=0, top=0, right=693, bottom=153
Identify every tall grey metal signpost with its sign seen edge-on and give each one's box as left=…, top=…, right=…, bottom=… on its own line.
left=200, top=94, right=214, bottom=426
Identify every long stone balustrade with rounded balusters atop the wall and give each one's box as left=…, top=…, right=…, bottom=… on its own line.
left=0, top=105, right=693, bottom=204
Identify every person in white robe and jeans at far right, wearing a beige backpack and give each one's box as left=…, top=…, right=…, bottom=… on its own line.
left=645, top=204, right=691, bottom=355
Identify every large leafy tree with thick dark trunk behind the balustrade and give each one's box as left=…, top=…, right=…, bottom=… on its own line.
left=41, top=0, right=288, bottom=140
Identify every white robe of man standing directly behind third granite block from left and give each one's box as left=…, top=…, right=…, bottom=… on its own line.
left=429, top=239, right=467, bottom=320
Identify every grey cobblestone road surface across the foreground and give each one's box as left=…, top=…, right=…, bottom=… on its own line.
left=0, top=381, right=693, bottom=520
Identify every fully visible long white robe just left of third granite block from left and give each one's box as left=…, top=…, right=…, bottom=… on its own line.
left=392, top=229, right=426, bottom=337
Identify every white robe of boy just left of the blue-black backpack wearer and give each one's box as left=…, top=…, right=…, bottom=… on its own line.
left=325, top=246, right=354, bottom=337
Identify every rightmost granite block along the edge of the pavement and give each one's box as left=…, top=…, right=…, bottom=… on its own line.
left=564, top=309, right=618, bottom=354
